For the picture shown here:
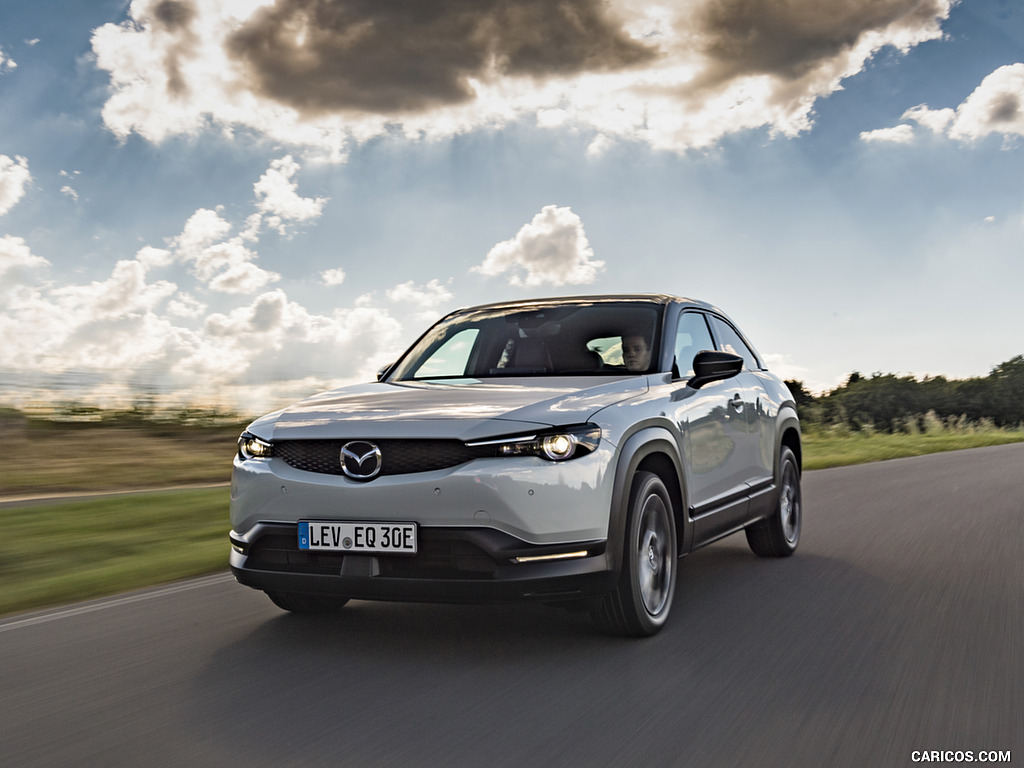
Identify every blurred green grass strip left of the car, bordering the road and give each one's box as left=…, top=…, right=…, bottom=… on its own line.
left=0, top=487, right=229, bottom=614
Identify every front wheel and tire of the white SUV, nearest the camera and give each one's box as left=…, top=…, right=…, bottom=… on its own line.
left=594, top=472, right=678, bottom=637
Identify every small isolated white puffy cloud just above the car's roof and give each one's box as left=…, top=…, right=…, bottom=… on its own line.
left=472, top=206, right=604, bottom=286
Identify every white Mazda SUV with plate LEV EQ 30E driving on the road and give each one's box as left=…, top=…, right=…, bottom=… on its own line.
left=230, top=295, right=801, bottom=636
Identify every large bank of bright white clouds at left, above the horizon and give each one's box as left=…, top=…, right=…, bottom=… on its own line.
left=0, top=158, right=409, bottom=411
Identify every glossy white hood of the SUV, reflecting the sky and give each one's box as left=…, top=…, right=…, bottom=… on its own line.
left=249, top=376, right=647, bottom=440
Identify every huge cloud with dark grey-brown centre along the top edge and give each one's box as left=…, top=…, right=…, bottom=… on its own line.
left=92, top=0, right=954, bottom=160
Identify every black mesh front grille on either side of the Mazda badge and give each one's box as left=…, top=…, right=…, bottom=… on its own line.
left=273, top=439, right=497, bottom=475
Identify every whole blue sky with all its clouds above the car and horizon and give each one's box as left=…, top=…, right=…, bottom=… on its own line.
left=0, top=0, right=1024, bottom=414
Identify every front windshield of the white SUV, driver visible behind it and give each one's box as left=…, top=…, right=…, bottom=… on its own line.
left=389, top=301, right=662, bottom=381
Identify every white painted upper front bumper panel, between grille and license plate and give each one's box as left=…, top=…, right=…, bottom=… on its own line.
left=230, top=441, right=615, bottom=545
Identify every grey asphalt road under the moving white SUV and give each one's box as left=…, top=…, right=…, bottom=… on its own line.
left=0, top=443, right=1024, bottom=768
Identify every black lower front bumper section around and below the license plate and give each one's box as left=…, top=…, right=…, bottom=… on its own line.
left=230, top=523, right=617, bottom=602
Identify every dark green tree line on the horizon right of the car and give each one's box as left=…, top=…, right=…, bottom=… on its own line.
left=785, top=355, right=1024, bottom=433
